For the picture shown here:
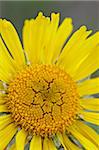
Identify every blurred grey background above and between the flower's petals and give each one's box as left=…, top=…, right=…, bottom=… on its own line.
left=0, top=1, right=99, bottom=149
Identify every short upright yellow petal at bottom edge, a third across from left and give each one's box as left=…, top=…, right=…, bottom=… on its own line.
left=30, top=135, right=42, bottom=150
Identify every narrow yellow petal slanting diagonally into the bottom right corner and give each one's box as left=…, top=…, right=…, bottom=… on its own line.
left=69, top=126, right=98, bottom=150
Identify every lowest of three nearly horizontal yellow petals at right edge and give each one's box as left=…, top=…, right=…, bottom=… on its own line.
left=80, top=111, right=99, bottom=125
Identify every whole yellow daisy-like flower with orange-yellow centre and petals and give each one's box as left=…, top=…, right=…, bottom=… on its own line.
left=0, top=12, right=99, bottom=150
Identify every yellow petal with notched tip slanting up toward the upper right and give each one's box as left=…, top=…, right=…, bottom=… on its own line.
left=58, top=26, right=91, bottom=66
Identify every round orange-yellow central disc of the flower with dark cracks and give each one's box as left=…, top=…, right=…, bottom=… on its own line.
left=6, top=65, right=79, bottom=136
